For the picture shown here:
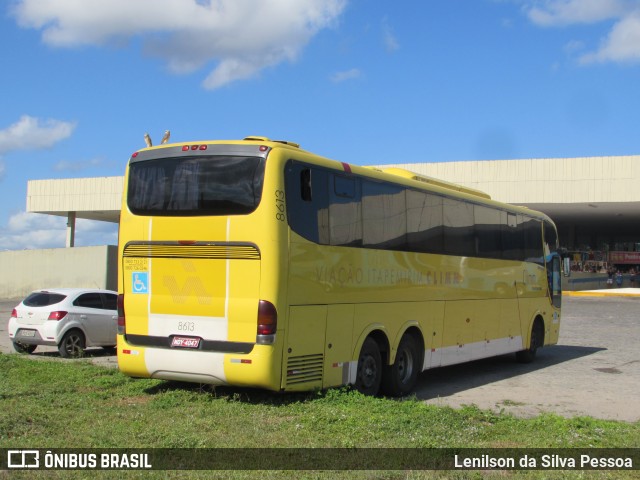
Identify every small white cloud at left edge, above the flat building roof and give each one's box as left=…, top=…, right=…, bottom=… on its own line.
left=0, top=115, right=75, bottom=154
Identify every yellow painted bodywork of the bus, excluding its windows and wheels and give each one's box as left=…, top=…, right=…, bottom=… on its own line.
left=118, top=139, right=560, bottom=391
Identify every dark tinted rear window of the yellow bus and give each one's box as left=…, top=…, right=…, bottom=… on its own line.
left=127, top=156, right=265, bottom=216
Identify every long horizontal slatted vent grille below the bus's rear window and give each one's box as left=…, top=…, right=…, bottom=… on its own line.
left=124, top=242, right=260, bottom=260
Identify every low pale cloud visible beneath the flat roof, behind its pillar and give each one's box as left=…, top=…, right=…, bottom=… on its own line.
left=0, top=212, right=118, bottom=250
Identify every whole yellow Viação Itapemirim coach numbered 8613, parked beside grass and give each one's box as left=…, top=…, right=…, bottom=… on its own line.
left=118, top=137, right=561, bottom=396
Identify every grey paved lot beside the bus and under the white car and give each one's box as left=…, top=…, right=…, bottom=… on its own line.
left=0, top=289, right=640, bottom=421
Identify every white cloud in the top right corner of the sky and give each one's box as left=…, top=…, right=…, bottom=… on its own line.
left=527, top=0, right=640, bottom=64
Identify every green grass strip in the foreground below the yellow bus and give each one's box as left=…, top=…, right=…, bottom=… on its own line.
left=0, top=354, right=640, bottom=478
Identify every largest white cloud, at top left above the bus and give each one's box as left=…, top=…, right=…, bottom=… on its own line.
left=13, top=0, right=347, bottom=89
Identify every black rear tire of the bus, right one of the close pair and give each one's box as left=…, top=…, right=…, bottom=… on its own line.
left=382, top=335, right=420, bottom=397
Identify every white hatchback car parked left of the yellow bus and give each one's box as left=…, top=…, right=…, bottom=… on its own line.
left=8, top=288, right=118, bottom=358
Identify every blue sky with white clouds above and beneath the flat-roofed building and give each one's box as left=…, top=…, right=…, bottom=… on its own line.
left=0, top=0, right=640, bottom=250
